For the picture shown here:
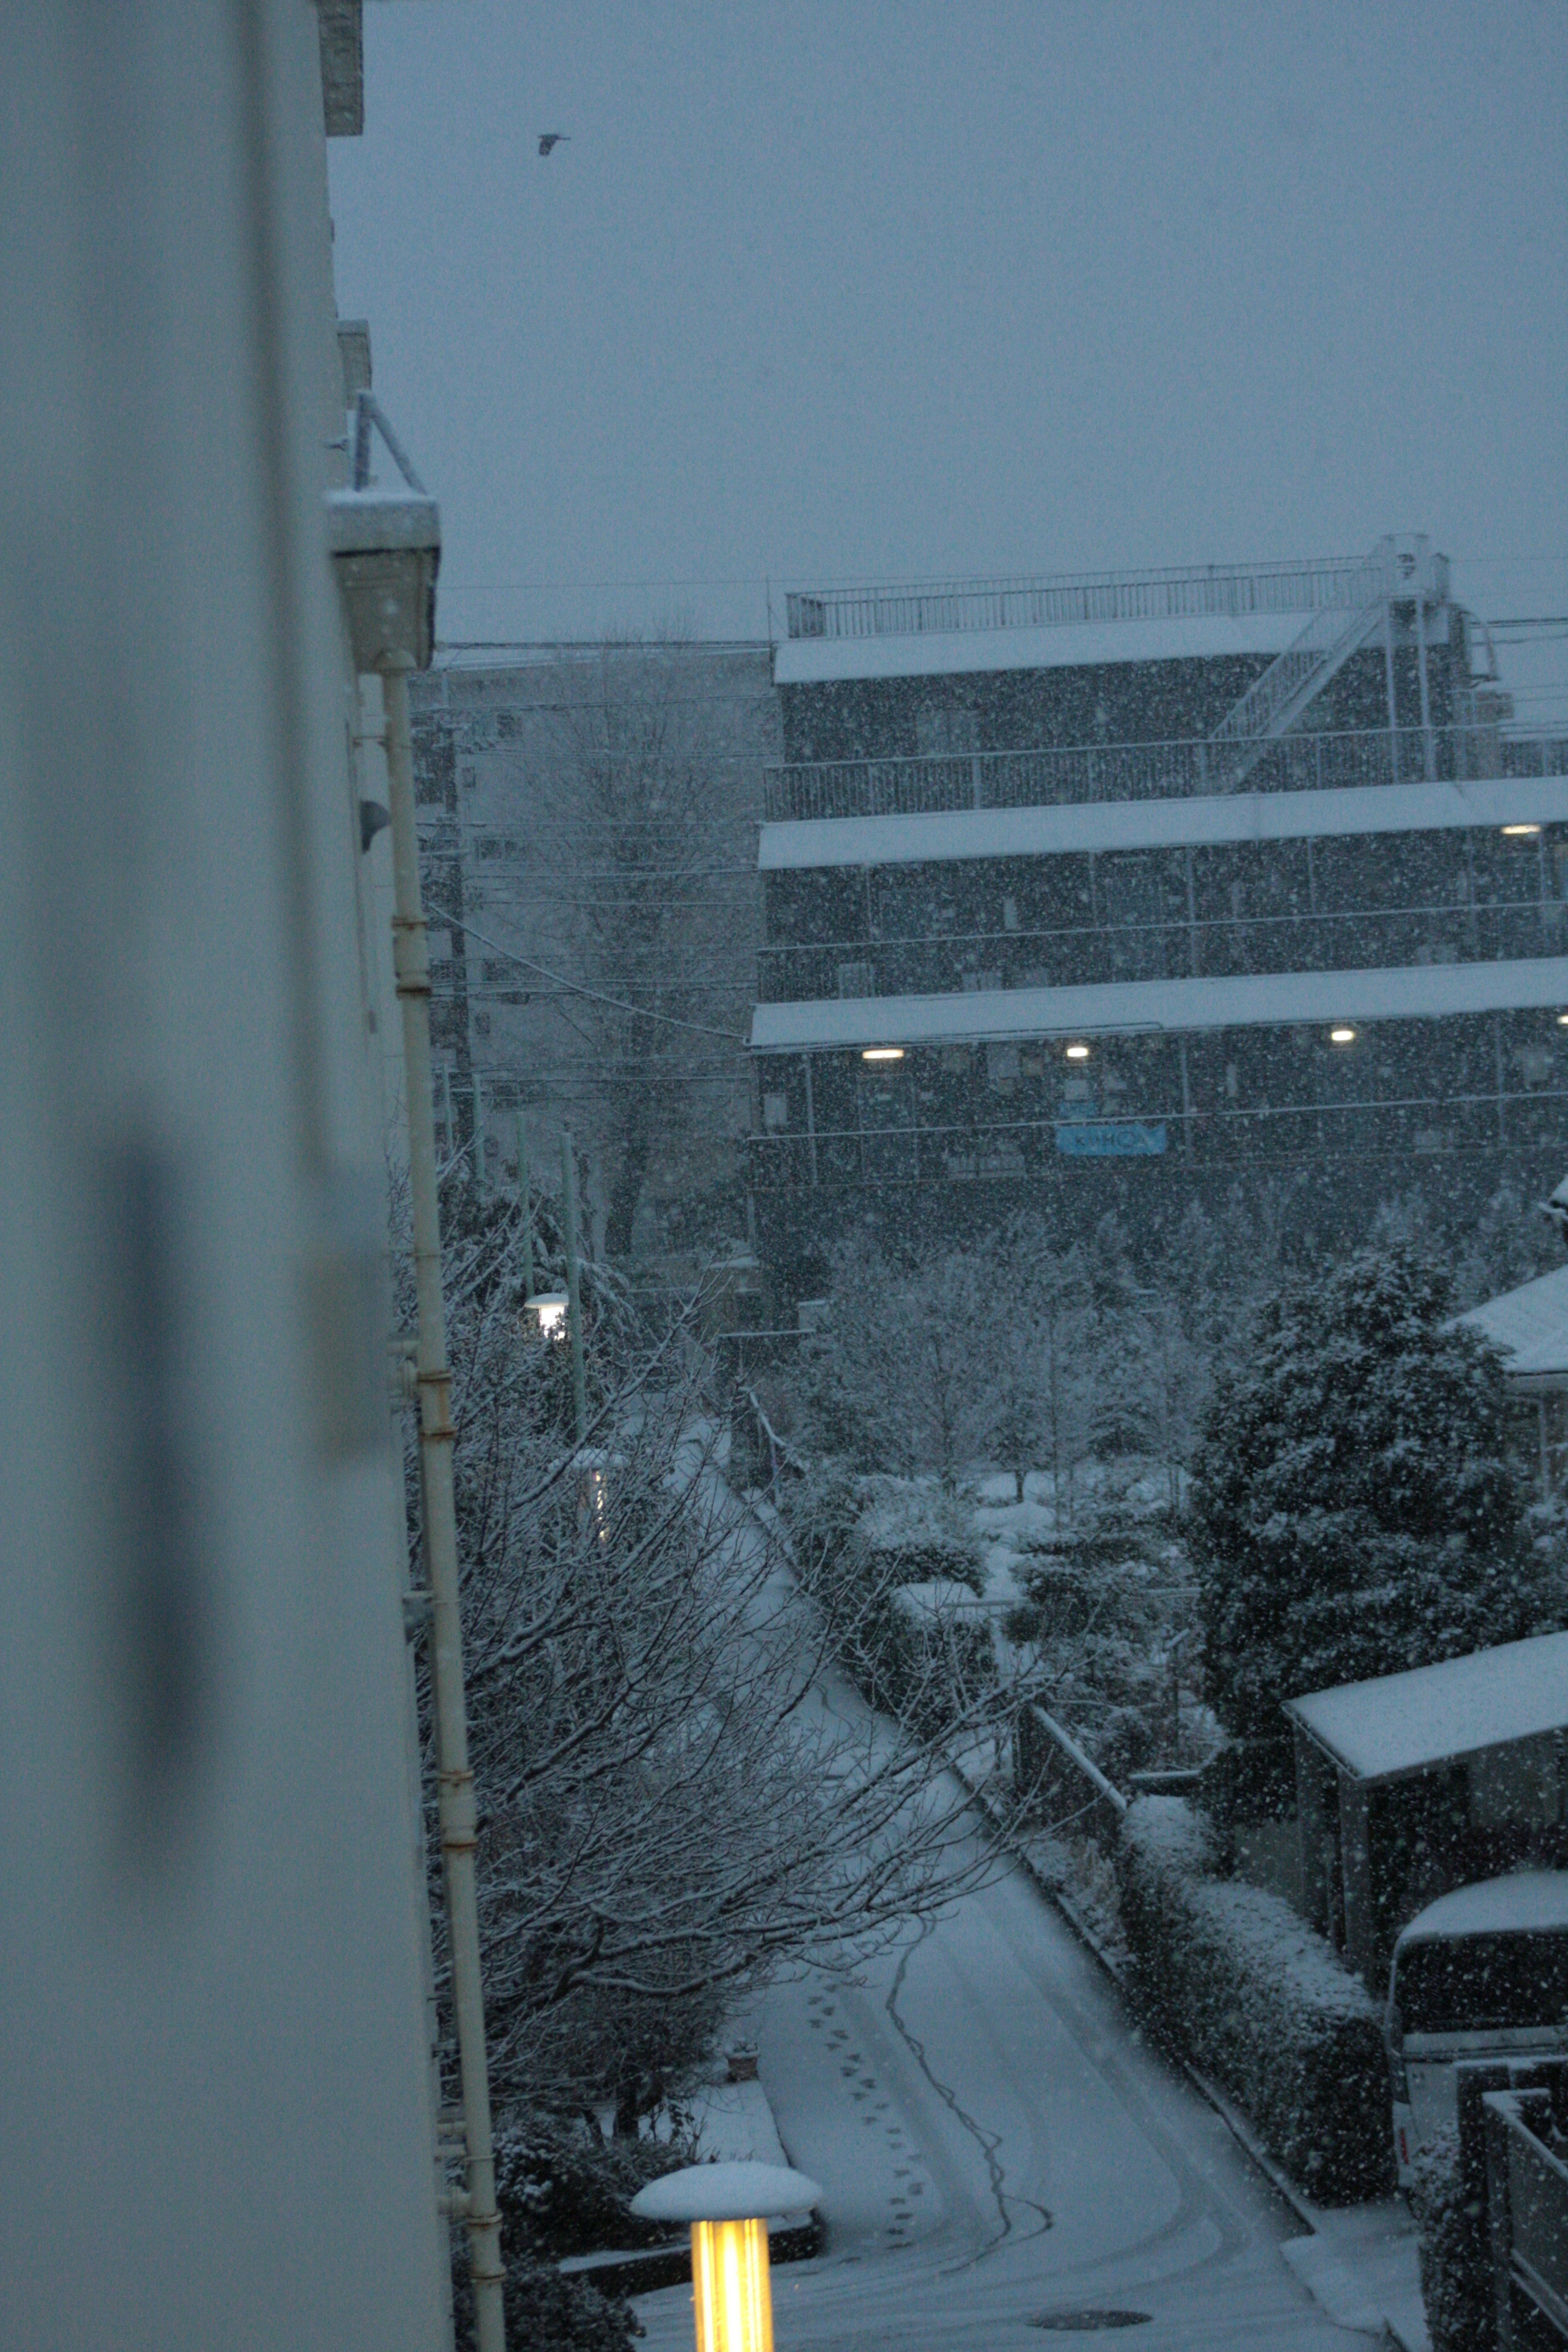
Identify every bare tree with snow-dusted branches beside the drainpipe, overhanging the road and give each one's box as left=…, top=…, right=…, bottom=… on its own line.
left=409, top=1204, right=982, bottom=2122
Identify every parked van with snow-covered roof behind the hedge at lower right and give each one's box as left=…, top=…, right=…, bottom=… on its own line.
left=1387, top=1870, right=1568, bottom=2187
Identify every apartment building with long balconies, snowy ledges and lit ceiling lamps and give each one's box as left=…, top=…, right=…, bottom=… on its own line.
left=752, top=536, right=1568, bottom=1303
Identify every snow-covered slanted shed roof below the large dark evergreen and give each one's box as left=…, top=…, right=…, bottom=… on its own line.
left=1286, top=1632, right=1568, bottom=1780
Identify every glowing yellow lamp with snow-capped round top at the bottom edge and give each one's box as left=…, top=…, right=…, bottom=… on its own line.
left=633, top=2164, right=823, bottom=2352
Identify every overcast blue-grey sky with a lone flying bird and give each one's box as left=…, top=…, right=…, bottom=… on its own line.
left=332, top=0, right=1568, bottom=715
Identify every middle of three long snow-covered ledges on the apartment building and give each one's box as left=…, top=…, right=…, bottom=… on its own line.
left=757, top=776, right=1568, bottom=873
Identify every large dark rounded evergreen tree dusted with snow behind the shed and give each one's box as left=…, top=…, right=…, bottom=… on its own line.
left=1192, top=1249, right=1552, bottom=1736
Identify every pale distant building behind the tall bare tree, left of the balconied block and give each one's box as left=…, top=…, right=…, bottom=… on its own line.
left=414, top=637, right=780, bottom=1263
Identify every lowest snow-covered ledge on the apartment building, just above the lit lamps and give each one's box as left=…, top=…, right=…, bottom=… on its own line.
left=752, top=955, right=1568, bottom=1054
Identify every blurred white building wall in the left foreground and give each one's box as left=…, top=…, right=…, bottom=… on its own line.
left=0, top=0, right=444, bottom=2352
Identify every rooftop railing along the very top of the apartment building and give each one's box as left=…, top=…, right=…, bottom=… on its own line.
left=785, top=555, right=1366, bottom=637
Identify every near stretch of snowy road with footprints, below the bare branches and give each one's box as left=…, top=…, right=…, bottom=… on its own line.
left=637, top=1834, right=1370, bottom=2352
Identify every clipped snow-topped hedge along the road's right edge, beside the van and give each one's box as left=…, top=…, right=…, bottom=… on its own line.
left=1117, top=1797, right=1392, bottom=2199
